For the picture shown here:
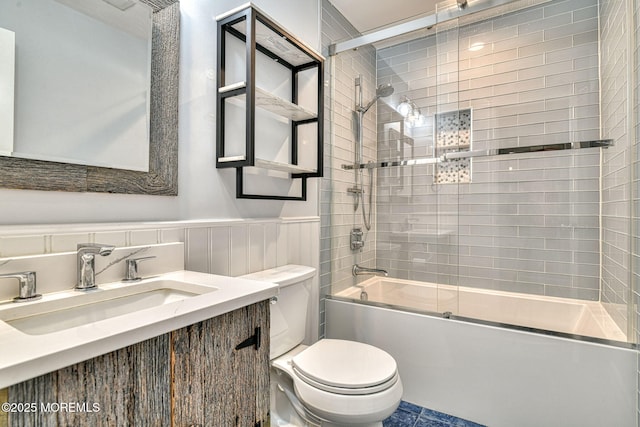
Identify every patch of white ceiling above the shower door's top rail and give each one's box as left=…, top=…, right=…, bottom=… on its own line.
left=330, top=0, right=442, bottom=33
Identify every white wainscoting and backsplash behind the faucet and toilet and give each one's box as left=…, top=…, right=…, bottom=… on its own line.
left=0, top=217, right=320, bottom=308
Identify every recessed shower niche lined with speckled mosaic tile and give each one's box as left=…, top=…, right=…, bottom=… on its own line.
left=433, top=108, right=471, bottom=184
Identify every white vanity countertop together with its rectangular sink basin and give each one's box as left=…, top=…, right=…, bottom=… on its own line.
left=0, top=270, right=278, bottom=392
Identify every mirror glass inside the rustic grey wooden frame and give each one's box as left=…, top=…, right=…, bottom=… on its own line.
left=0, top=0, right=153, bottom=172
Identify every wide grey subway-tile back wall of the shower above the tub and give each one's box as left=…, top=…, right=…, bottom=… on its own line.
left=376, top=0, right=610, bottom=300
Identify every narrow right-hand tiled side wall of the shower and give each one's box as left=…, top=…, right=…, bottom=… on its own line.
left=600, top=0, right=633, bottom=342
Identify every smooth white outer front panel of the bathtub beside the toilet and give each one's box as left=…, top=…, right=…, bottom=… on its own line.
left=325, top=298, right=638, bottom=427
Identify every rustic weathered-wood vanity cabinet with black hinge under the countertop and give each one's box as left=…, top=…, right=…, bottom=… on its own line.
left=0, top=301, right=270, bottom=427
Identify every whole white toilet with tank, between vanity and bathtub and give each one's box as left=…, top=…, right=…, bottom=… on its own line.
left=243, top=265, right=402, bottom=427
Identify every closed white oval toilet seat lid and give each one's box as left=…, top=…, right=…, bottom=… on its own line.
left=292, top=339, right=398, bottom=394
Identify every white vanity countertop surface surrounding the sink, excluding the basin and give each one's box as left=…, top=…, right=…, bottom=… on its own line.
left=0, top=271, right=278, bottom=388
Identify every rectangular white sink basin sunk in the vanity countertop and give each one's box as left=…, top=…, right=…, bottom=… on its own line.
left=0, top=279, right=218, bottom=335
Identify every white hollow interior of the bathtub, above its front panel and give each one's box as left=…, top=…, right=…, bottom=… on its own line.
left=335, top=277, right=626, bottom=341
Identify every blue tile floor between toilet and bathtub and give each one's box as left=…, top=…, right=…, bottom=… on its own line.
left=382, top=401, right=484, bottom=427
